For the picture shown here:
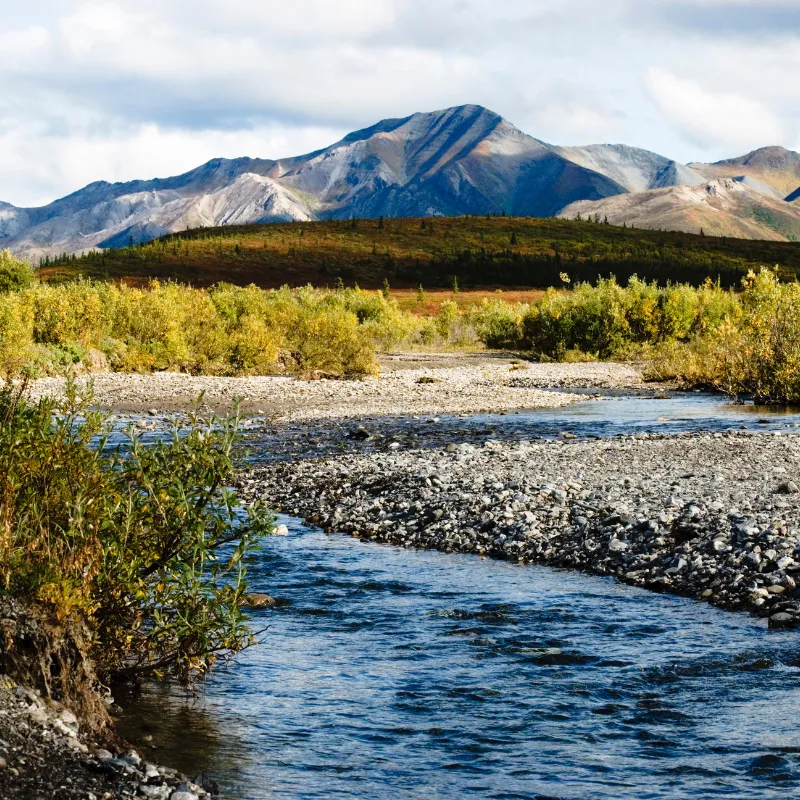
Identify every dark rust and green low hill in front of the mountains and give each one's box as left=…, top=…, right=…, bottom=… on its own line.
left=41, top=216, right=800, bottom=288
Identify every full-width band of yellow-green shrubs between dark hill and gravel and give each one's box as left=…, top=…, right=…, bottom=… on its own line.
left=0, top=220, right=800, bottom=403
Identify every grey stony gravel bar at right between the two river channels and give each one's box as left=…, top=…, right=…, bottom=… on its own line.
left=241, top=432, right=800, bottom=627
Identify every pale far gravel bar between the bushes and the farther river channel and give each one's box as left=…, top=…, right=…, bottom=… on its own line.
left=20, top=353, right=643, bottom=422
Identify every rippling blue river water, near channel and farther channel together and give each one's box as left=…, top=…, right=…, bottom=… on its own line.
left=120, top=398, right=800, bottom=800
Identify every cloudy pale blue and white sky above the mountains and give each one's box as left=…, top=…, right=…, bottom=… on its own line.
left=0, top=0, right=800, bottom=206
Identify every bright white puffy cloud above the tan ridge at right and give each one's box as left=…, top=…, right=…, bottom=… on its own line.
left=646, top=68, right=786, bottom=150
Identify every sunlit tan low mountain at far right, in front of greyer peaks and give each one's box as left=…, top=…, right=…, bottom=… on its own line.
left=559, top=176, right=800, bottom=241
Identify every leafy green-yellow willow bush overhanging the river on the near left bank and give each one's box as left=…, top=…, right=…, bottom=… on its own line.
left=0, top=384, right=272, bottom=684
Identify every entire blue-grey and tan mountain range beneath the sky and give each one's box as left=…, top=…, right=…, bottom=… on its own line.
left=0, top=105, right=800, bottom=260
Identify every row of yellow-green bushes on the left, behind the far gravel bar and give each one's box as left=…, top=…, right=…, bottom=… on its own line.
left=0, top=280, right=400, bottom=375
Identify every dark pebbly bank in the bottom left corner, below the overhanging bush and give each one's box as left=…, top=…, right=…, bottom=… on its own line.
left=0, top=676, right=216, bottom=800
